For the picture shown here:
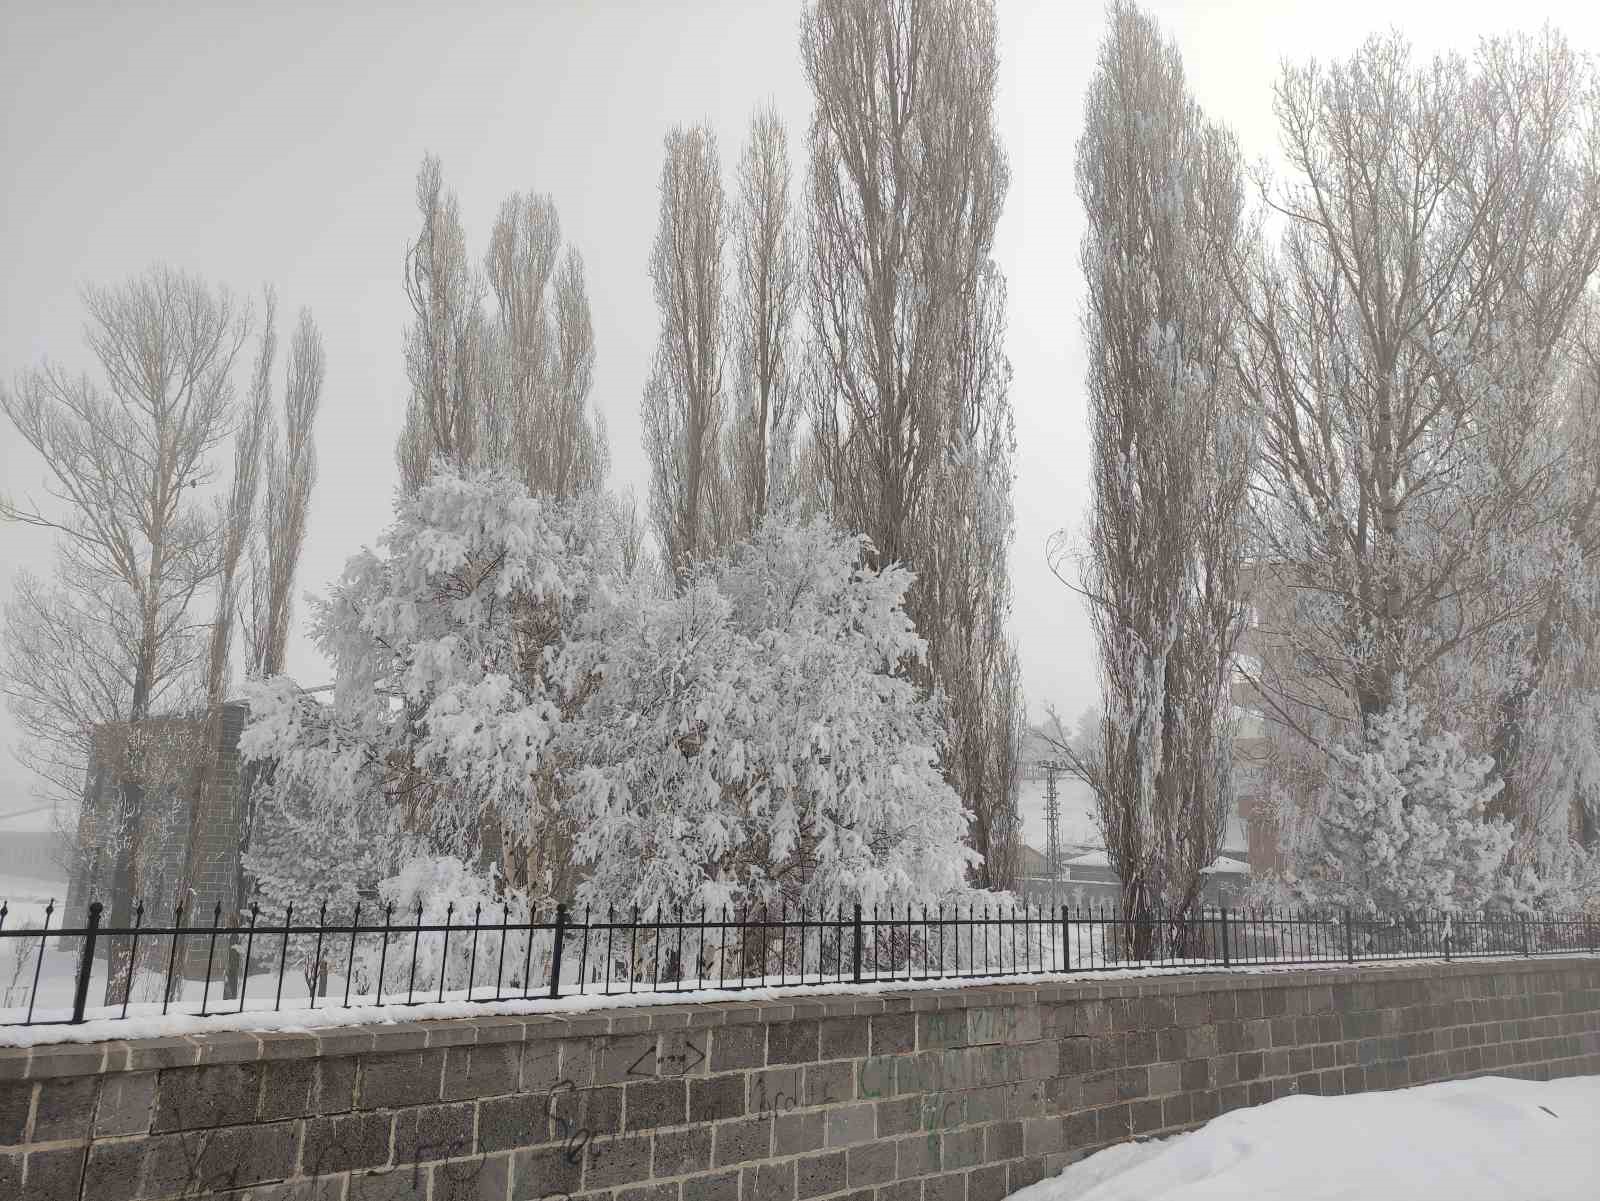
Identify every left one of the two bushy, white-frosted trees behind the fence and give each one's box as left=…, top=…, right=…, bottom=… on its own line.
left=240, top=472, right=597, bottom=901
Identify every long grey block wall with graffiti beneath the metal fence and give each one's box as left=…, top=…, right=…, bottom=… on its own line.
left=0, top=956, right=1600, bottom=1201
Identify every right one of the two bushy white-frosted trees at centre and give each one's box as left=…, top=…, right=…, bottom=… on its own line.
left=566, top=517, right=974, bottom=912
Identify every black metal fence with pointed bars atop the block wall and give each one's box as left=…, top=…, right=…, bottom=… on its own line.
left=0, top=902, right=1600, bottom=1025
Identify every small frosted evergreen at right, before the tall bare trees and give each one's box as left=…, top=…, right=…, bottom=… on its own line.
left=1310, top=680, right=1514, bottom=915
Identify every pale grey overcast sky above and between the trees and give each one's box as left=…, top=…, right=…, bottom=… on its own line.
left=0, top=0, right=1600, bottom=836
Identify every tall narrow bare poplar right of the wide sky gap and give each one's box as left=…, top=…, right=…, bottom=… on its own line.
left=1058, top=3, right=1251, bottom=956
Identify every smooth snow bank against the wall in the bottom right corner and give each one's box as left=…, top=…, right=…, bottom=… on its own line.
left=1011, top=1076, right=1600, bottom=1201
